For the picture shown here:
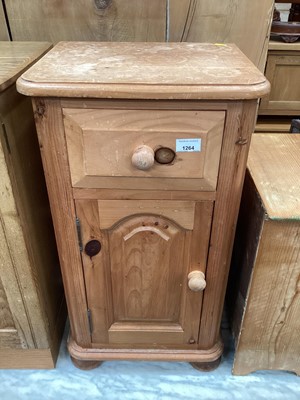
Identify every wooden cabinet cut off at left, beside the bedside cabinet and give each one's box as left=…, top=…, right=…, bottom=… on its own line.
left=0, top=42, right=66, bottom=368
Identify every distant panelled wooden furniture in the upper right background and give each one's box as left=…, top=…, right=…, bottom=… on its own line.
left=259, top=40, right=300, bottom=116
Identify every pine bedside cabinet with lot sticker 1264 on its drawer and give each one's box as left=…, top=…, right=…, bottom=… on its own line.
left=18, top=42, right=269, bottom=368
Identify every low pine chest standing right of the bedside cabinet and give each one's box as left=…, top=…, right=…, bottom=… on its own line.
left=228, top=134, right=300, bottom=375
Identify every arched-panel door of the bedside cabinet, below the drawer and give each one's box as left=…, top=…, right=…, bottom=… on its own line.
left=76, top=200, right=213, bottom=347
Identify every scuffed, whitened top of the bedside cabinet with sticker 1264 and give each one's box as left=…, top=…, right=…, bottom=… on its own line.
left=18, top=42, right=269, bottom=100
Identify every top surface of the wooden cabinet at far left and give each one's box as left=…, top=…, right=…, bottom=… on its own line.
left=0, top=42, right=51, bottom=92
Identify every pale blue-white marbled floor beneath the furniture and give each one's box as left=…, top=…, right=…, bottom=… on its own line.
left=0, top=324, right=300, bottom=400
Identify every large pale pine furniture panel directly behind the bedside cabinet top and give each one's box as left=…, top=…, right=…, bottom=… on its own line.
left=4, top=0, right=273, bottom=71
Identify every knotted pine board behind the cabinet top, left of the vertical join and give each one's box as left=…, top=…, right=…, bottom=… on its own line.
left=5, top=0, right=166, bottom=43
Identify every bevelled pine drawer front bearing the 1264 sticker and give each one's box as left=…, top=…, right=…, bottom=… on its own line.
left=64, top=109, right=225, bottom=191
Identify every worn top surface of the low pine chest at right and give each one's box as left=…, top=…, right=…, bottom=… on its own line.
left=248, top=133, right=300, bottom=221
